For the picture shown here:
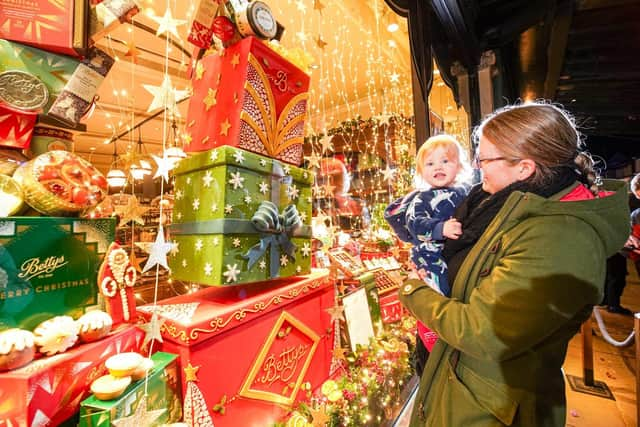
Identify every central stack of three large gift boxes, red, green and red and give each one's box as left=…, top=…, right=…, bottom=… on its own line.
left=138, top=6, right=336, bottom=427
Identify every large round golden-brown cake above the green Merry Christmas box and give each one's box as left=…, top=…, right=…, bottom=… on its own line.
left=13, top=150, right=108, bottom=215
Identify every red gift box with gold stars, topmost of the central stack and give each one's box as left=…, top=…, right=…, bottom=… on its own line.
left=185, top=37, right=309, bottom=166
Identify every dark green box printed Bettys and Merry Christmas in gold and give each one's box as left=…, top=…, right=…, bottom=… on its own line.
left=0, top=217, right=115, bottom=330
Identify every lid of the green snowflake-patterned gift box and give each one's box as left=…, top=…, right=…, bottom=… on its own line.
left=174, top=145, right=313, bottom=185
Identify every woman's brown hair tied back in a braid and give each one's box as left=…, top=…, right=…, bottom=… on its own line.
left=474, top=102, right=598, bottom=194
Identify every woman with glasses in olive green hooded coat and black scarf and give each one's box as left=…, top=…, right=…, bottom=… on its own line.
left=400, top=103, right=629, bottom=427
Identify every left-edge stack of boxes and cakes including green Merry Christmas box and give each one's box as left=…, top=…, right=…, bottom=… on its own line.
left=0, top=0, right=179, bottom=426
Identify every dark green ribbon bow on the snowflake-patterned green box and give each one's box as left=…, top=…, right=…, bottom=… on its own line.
left=242, top=200, right=302, bottom=279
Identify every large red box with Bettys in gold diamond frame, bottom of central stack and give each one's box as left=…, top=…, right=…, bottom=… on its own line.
left=138, top=272, right=334, bottom=427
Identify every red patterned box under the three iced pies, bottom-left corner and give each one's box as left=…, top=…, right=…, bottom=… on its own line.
left=0, top=325, right=144, bottom=427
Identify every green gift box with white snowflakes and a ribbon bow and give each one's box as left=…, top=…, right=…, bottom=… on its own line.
left=169, top=146, right=313, bottom=286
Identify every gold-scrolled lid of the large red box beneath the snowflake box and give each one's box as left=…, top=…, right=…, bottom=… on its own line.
left=138, top=270, right=333, bottom=346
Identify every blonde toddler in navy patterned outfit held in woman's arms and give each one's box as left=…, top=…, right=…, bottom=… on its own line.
left=384, top=135, right=471, bottom=373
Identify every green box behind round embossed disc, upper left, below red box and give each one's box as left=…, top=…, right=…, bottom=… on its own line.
left=0, top=39, right=80, bottom=113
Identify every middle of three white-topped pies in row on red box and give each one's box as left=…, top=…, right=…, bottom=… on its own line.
left=33, top=316, right=79, bottom=356
